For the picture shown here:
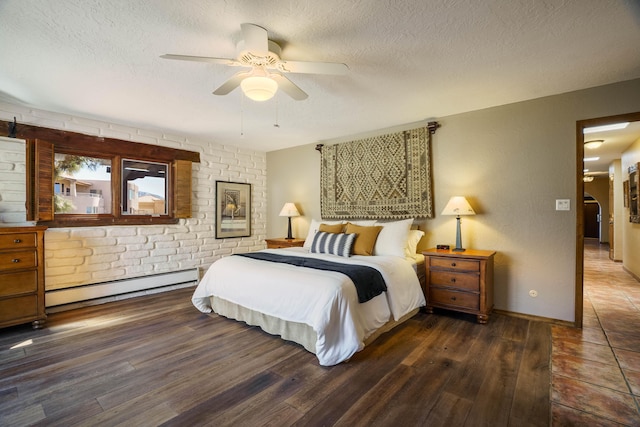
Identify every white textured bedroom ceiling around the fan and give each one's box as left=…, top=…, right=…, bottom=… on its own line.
left=0, top=0, right=640, bottom=151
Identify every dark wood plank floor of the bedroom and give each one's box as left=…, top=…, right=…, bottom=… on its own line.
left=0, top=289, right=551, bottom=426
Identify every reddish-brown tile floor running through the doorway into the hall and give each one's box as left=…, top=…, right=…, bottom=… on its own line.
left=551, top=241, right=640, bottom=426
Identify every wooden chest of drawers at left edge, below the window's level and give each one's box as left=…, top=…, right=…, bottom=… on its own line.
left=0, top=227, right=47, bottom=329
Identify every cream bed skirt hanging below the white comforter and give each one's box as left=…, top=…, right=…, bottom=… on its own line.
left=211, top=297, right=420, bottom=354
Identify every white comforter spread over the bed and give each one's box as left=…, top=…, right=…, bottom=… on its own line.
left=192, top=248, right=425, bottom=366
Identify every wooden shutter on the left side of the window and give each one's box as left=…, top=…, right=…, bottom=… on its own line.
left=27, top=139, right=54, bottom=221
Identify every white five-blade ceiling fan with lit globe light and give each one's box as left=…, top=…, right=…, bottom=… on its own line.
left=160, top=24, right=349, bottom=101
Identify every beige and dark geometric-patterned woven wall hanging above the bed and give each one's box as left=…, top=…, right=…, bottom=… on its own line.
left=318, top=122, right=439, bottom=219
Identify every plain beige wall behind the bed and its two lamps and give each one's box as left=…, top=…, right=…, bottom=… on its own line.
left=267, top=80, right=640, bottom=321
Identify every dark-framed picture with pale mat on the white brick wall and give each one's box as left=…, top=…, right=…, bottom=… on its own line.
left=216, top=181, right=251, bottom=239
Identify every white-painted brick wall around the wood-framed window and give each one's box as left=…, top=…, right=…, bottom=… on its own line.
left=0, top=102, right=267, bottom=300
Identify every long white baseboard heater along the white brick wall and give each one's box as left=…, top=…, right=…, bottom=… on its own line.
left=45, top=268, right=199, bottom=308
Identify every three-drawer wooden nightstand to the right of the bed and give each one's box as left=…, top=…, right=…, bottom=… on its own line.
left=423, top=249, right=495, bottom=323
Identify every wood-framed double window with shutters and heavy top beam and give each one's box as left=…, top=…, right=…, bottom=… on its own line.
left=18, top=125, right=200, bottom=227
